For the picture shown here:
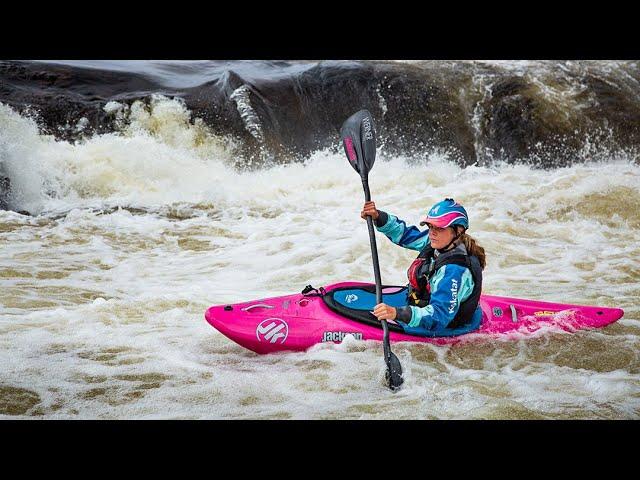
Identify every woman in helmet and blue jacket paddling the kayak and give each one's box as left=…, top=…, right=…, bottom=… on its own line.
left=360, top=198, right=486, bottom=335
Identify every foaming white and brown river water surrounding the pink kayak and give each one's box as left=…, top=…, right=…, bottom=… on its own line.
left=0, top=97, right=640, bottom=418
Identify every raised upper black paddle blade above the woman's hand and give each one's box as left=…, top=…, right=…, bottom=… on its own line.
left=340, top=110, right=376, bottom=177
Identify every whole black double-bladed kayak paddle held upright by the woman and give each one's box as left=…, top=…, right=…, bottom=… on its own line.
left=340, top=110, right=403, bottom=391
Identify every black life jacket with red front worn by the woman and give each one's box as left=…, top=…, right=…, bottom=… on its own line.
left=407, top=243, right=482, bottom=328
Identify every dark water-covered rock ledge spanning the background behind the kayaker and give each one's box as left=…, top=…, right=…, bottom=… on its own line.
left=0, top=61, right=640, bottom=176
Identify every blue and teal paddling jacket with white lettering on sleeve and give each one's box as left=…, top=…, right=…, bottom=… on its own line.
left=375, top=210, right=474, bottom=335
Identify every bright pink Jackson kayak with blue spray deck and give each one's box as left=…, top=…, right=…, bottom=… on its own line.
left=205, top=282, right=624, bottom=353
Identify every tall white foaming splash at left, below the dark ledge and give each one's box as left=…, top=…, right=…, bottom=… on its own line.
left=0, top=96, right=234, bottom=213
